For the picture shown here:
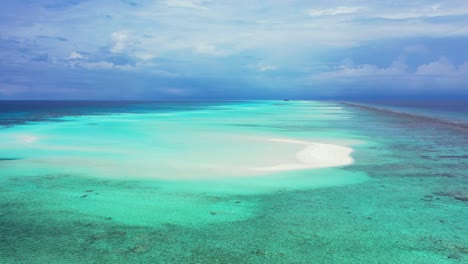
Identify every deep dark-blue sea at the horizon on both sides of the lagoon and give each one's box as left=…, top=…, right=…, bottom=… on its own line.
left=0, top=100, right=468, bottom=125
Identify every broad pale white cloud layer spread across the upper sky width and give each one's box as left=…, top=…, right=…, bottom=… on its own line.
left=0, top=0, right=468, bottom=89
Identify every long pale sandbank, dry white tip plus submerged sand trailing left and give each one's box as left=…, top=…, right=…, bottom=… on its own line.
left=6, top=134, right=353, bottom=180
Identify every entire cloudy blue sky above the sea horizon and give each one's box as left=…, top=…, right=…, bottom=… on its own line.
left=0, top=0, right=468, bottom=100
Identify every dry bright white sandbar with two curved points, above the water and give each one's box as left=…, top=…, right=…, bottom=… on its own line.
left=252, top=138, right=354, bottom=172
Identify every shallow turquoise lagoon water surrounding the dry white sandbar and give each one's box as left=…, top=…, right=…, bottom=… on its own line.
left=0, top=101, right=468, bottom=263
